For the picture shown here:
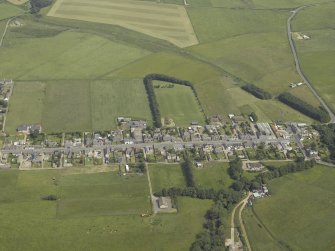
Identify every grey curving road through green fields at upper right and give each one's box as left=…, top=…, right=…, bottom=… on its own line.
left=287, top=5, right=335, bottom=123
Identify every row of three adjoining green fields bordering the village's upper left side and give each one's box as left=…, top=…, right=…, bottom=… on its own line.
left=6, top=79, right=151, bottom=133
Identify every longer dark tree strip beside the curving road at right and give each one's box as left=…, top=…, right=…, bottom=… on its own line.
left=278, top=92, right=330, bottom=123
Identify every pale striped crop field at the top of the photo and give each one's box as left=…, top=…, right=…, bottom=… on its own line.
left=48, top=0, right=198, bottom=47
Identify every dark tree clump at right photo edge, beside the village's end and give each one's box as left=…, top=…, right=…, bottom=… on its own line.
left=314, top=124, right=335, bottom=162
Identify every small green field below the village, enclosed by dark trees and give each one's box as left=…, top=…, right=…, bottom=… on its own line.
left=193, top=162, right=234, bottom=190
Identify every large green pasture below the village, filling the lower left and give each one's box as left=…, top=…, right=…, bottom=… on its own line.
left=0, top=170, right=212, bottom=251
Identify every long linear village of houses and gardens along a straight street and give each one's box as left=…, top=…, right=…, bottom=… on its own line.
left=0, top=114, right=326, bottom=172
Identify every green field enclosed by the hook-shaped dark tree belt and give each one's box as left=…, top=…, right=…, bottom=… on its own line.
left=153, top=81, right=205, bottom=127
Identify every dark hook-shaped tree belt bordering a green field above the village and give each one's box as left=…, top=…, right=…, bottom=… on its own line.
left=143, top=73, right=202, bottom=128
